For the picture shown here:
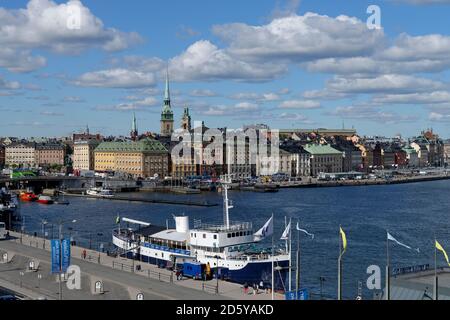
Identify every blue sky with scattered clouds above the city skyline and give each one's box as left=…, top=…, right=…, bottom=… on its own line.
left=0, top=0, right=450, bottom=138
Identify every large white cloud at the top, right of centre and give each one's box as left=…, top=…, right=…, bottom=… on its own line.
left=213, top=12, right=384, bottom=62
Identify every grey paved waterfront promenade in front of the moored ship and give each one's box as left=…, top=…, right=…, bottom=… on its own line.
left=0, top=232, right=284, bottom=300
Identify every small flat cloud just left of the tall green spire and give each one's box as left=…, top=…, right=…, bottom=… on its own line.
left=72, top=69, right=156, bottom=89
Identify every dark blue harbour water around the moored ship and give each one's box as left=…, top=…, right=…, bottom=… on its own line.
left=15, top=180, right=450, bottom=299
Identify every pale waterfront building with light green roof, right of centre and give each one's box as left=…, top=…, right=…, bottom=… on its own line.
left=304, top=144, right=343, bottom=177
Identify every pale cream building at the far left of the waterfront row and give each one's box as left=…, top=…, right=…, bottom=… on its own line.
left=5, top=141, right=37, bottom=168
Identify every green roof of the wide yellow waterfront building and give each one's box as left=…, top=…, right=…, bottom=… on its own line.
left=95, top=138, right=167, bottom=153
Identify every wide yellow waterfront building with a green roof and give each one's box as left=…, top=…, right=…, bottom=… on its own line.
left=94, top=138, right=169, bottom=178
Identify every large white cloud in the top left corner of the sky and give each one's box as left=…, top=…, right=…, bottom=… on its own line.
left=0, top=0, right=142, bottom=72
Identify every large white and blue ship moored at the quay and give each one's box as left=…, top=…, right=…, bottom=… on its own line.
left=113, top=176, right=290, bottom=290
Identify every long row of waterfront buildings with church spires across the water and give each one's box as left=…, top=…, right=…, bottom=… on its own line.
left=0, top=73, right=450, bottom=179
